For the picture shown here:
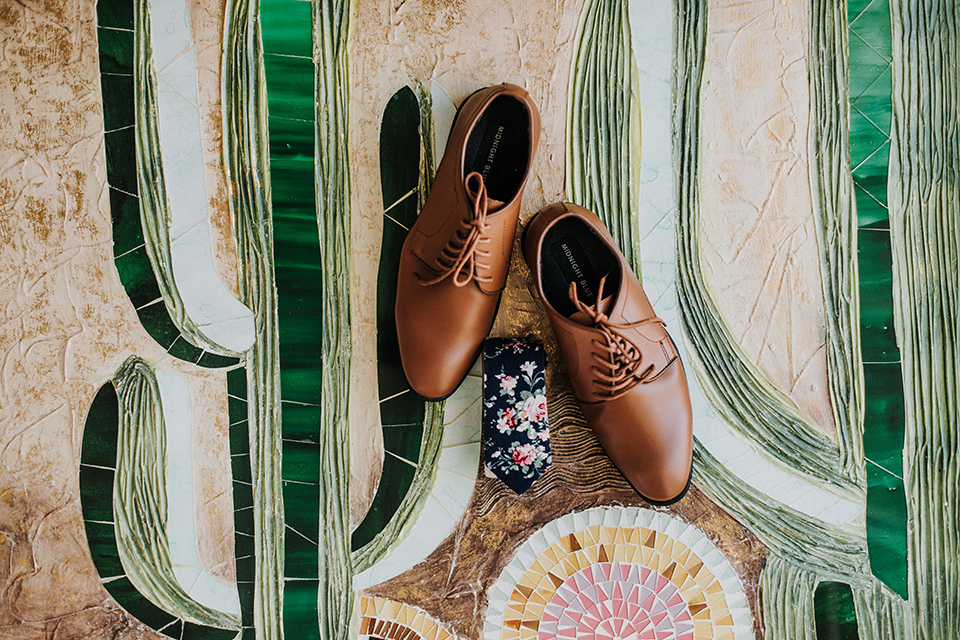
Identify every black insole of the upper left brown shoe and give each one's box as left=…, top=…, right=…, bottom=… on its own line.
left=463, top=96, right=530, bottom=202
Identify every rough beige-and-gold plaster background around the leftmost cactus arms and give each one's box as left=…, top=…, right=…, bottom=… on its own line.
left=0, top=0, right=233, bottom=638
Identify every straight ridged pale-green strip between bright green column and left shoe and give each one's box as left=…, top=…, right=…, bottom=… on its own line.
left=313, top=0, right=353, bottom=640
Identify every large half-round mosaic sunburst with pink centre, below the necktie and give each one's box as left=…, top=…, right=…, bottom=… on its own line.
left=483, top=507, right=753, bottom=640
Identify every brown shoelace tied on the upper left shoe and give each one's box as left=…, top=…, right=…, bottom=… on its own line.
left=420, top=171, right=493, bottom=287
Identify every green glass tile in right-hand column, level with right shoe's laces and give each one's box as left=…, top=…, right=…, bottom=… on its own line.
left=857, top=229, right=900, bottom=362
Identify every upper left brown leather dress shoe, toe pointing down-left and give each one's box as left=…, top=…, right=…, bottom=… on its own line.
left=396, top=84, right=540, bottom=399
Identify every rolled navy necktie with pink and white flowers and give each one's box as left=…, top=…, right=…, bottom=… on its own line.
left=483, top=338, right=551, bottom=493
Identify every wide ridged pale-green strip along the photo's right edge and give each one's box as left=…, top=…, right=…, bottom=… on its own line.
left=889, top=0, right=960, bottom=638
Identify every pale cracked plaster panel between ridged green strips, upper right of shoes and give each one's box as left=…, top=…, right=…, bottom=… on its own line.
left=700, top=0, right=836, bottom=437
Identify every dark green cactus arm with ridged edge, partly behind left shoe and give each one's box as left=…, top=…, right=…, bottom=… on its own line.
left=351, top=86, right=443, bottom=572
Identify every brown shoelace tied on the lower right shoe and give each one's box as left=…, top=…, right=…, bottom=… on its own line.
left=568, top=276, right=666, bottom=400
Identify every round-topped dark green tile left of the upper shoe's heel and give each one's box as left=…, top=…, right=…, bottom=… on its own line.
left=380, top=87, right=421, bottom=208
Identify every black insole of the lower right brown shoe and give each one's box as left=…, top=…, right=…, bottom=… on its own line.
left=540, top=218, right=620, bottom=317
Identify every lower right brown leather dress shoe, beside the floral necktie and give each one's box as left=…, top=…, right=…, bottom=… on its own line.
left=523, top=203, right=693, bottom=505
